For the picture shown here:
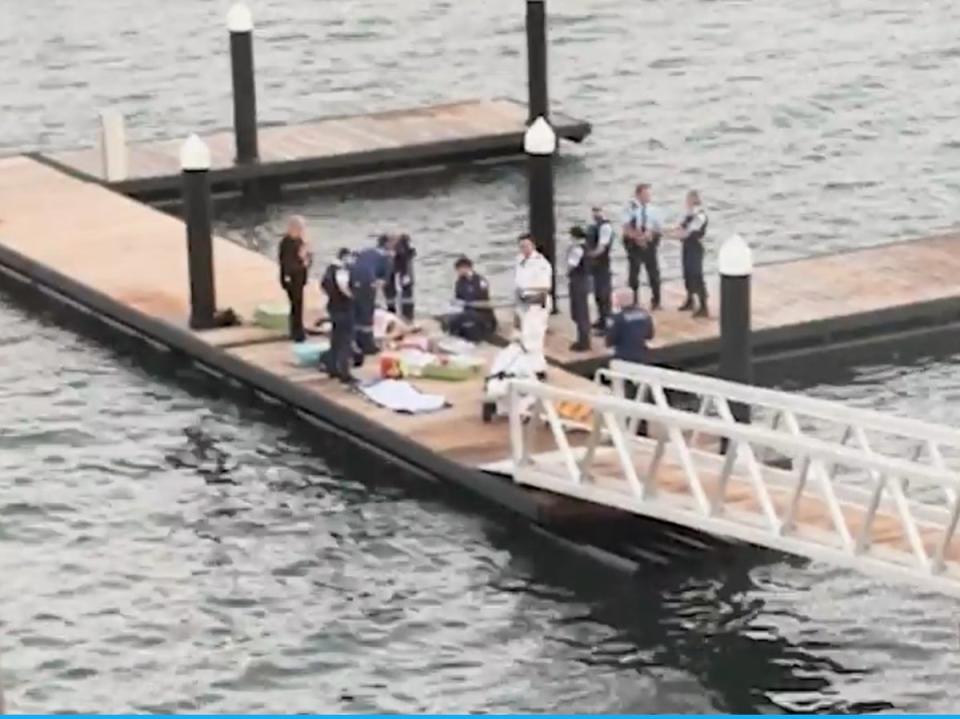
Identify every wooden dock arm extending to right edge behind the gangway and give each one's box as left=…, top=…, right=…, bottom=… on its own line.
left=547, top=233, right=960, bottom=372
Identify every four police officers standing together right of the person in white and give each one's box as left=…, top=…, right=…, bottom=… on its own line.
left=567, top=183, right=710, bottom=352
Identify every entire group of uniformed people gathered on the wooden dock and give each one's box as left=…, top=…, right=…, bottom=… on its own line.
left=279, top=183, right=709, bottom=382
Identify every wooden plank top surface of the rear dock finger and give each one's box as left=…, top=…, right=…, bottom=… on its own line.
left=37, top=99, right=583, bottom=188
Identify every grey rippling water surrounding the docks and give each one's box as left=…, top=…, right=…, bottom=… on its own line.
left=0, top=0, right=960, bottom=711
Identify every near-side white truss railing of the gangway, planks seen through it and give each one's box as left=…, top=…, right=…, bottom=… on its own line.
left=502, top=379, right=960, bottom=597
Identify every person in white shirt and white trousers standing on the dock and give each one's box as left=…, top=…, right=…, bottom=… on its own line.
left=514, top=235, right=553, bottom=379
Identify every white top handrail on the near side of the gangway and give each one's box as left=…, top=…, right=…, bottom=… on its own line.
left=510, top=379, right=960, bottom=490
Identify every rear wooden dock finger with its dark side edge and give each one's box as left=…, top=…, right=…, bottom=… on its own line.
left=37, top=99, right=590, bottom=198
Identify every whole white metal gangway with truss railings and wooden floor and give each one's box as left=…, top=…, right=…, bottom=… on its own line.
left=488, top=362, right=960, bottom=596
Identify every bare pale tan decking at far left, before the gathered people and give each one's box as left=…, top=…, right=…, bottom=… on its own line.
left=0, top=157, right=322, bottom=324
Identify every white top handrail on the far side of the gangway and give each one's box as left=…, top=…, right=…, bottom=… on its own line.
left=595, top=360, right=960, bottom=449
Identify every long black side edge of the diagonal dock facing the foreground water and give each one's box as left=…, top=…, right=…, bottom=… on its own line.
left=0, top=244, right=547, bottom=524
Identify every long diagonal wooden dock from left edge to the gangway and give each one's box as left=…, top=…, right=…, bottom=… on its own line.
left=0, top=156, right=604, bottom=520
